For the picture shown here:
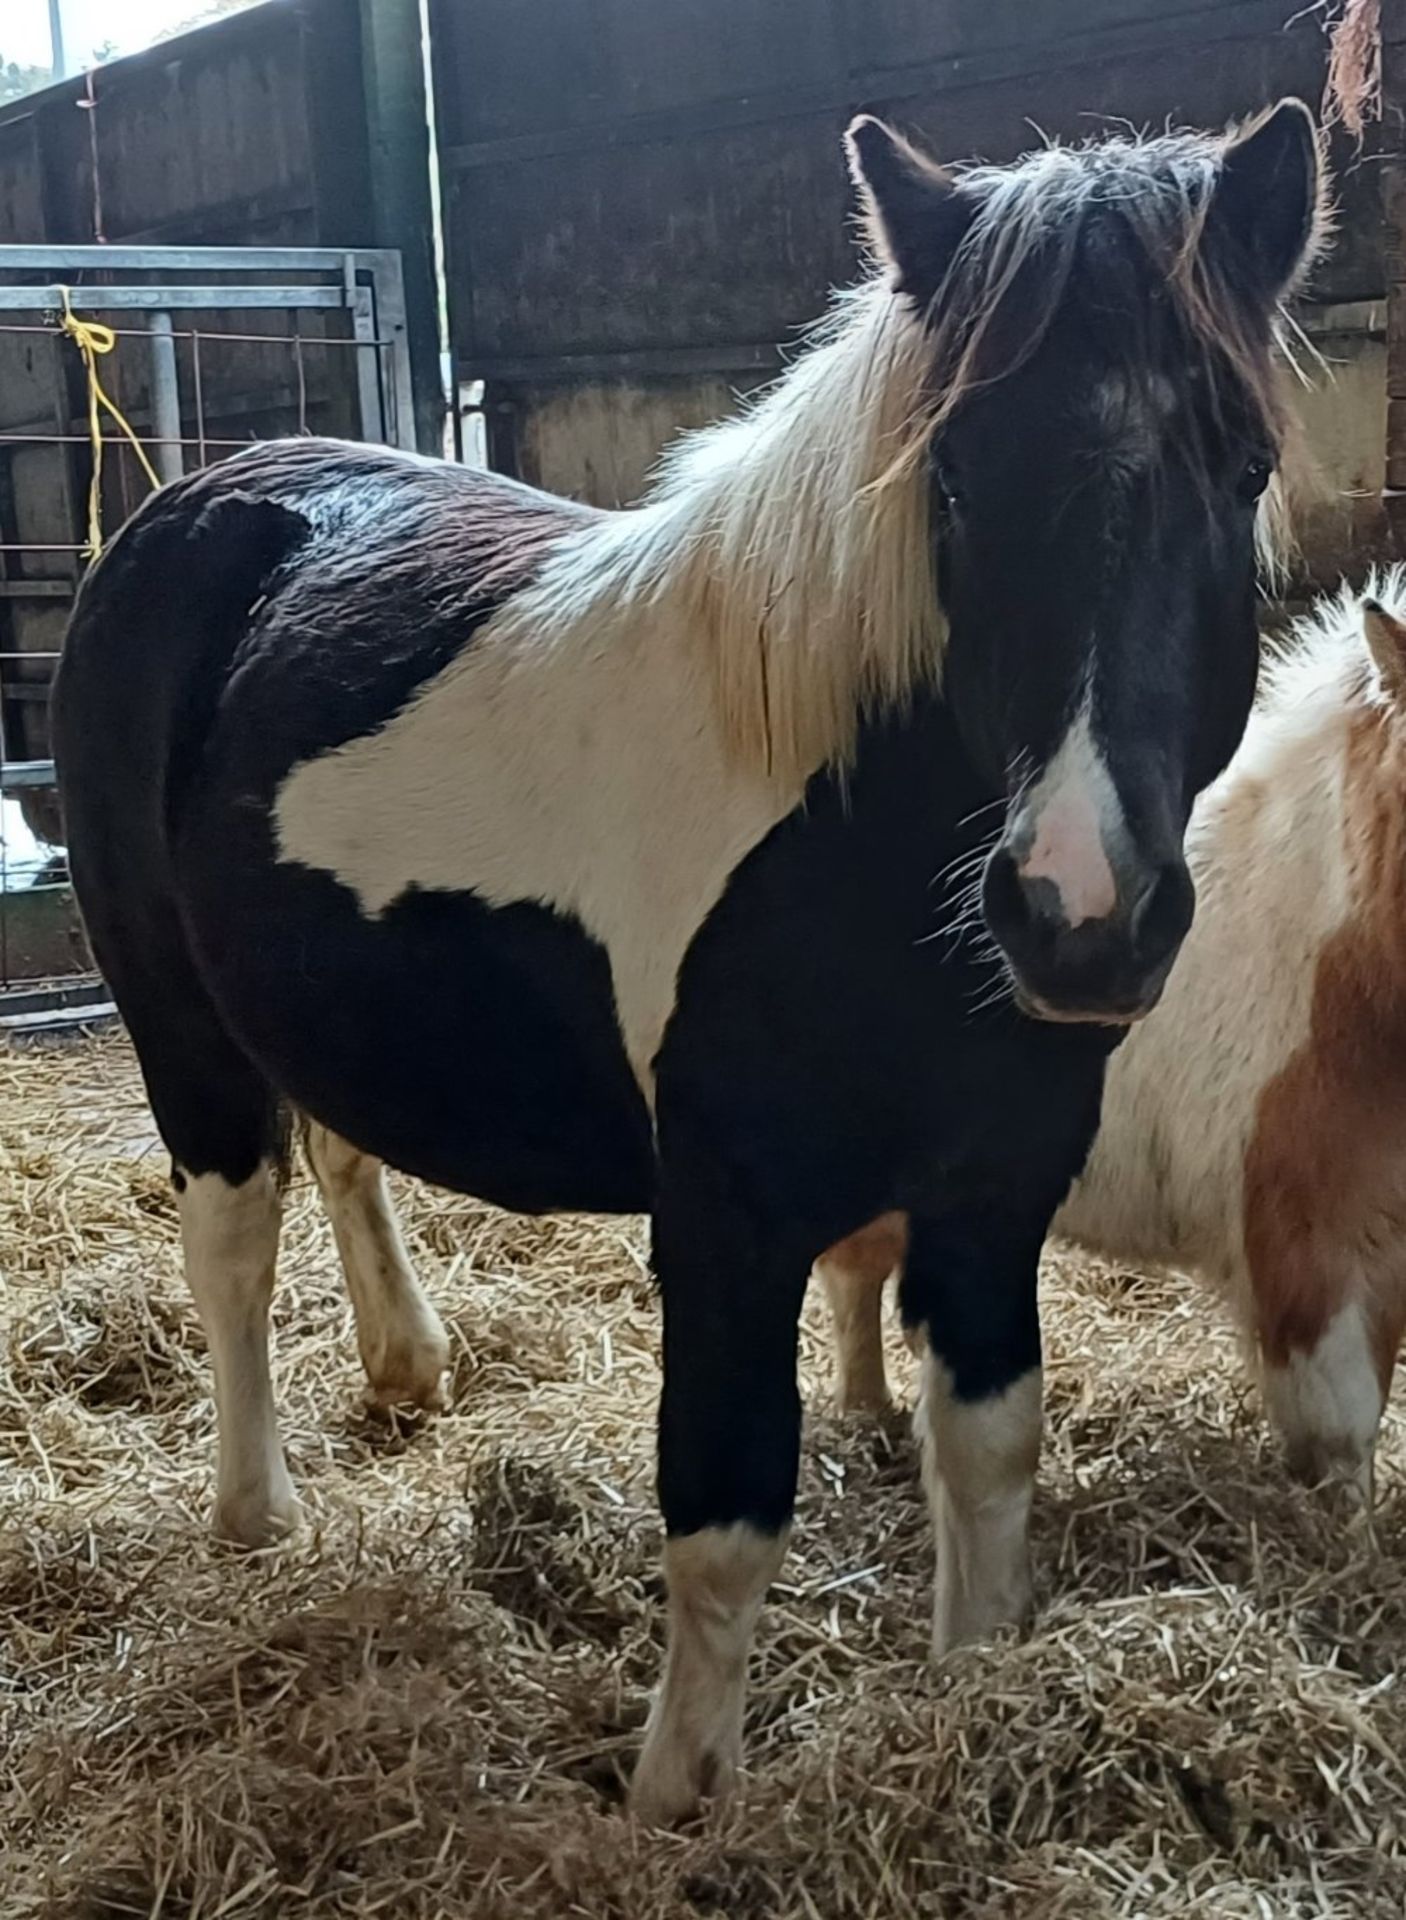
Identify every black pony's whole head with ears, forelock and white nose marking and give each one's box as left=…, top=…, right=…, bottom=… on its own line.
left=849, top=102, right=1323, bottom=1021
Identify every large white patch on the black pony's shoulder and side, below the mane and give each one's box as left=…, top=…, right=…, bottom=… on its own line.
left=275, top=533, right=805, bottom=1092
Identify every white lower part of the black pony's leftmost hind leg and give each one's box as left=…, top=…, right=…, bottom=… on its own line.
left=177, top=1164, right=298, bottom=1548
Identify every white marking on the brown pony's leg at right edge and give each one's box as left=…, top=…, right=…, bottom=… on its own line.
left=1262, top=1300, right=1383, bottom=1505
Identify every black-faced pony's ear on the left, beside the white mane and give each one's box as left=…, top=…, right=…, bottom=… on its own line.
left=845, top=113, right=970, bottom=311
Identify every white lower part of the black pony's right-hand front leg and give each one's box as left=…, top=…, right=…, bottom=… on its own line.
left=916, top=1354, right=1043, bottom=1659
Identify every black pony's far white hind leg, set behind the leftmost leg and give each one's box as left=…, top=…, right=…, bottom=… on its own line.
left=303, top=1119, right=449, bottom=1411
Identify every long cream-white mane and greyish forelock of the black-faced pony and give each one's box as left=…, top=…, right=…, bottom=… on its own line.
left=511, top=120, right=1321, bottom=781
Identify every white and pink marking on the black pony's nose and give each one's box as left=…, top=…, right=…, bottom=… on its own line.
left=1010, top=699, right=1127, bottom=927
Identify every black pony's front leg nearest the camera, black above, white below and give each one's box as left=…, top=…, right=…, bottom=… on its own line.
left=630, top=1200, right=809, bottom=1824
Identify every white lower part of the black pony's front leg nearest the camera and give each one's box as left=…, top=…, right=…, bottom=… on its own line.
left=630, top=1521, right=789, bottom=1826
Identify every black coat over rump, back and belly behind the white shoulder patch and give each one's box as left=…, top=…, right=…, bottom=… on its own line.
left=56, top=440, right=651, bottom=1210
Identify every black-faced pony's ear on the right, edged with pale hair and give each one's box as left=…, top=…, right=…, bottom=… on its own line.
left=1208, top=100, right=1327, bottom=300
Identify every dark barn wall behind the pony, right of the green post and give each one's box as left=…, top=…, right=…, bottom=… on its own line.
left=430, top=0, right=1385, bottom=568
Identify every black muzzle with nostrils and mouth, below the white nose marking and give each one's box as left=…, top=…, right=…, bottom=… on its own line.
left=982, top=843, right=1195, bottom=1025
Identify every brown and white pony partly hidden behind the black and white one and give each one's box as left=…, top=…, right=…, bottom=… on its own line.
left=816, top=566, right=1406, bottom=1500
